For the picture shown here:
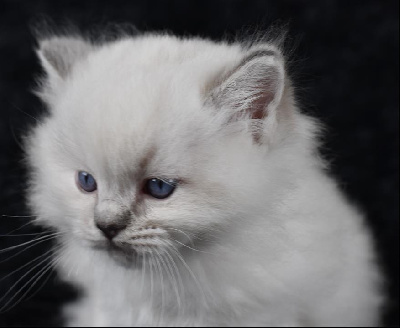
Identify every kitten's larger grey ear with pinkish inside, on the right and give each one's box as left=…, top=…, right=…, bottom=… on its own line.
left=208, top=46, right=285, bottom=141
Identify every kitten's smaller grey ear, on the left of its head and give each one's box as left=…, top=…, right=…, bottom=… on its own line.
left=37, top=37, right=94, bottom=100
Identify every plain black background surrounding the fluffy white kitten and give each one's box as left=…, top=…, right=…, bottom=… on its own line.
left=0, top=0, right=399, bottom=326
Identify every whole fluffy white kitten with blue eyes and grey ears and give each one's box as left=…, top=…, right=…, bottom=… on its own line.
left=26, top=30, right=383, bottom=326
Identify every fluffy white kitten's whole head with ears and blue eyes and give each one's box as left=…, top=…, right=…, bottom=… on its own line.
left=27, top=35, right=316, bottom=262
